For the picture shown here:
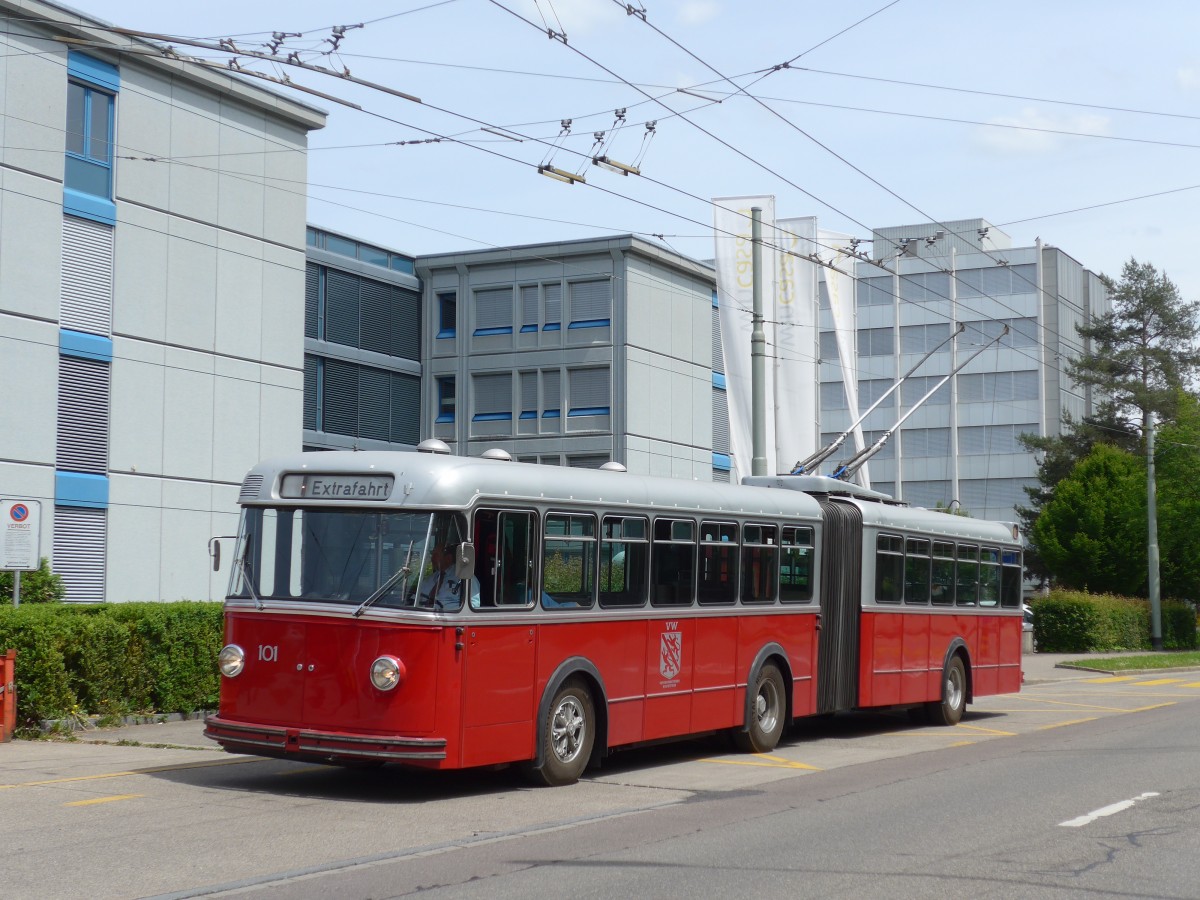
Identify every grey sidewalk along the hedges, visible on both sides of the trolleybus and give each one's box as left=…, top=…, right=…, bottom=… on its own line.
left=2, top=653, right=1185, bottom=762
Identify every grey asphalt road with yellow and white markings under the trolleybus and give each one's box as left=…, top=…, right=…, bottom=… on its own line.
left=0, top=673, right=1200, bottom=898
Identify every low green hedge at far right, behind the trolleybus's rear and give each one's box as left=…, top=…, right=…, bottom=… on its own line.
left=1031, top=590, right=1196, bottom=653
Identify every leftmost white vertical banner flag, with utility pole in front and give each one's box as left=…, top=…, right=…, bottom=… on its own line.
left=713, top=196, right=778, bottom=484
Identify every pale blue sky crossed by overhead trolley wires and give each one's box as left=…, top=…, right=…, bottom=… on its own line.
left=72, top=0, right=1200, bottom=300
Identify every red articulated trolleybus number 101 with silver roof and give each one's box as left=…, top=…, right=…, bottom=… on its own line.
left=205, top=451, right=1021, bottom=785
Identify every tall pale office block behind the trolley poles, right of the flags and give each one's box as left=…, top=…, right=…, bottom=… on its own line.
left=820, top=220, right=1109, bottom=521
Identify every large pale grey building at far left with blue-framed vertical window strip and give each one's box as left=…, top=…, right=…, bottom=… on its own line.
left=0, top=0, right=325, bottom=601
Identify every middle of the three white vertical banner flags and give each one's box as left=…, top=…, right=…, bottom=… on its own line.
left=767, top=216, right=820, bottom=474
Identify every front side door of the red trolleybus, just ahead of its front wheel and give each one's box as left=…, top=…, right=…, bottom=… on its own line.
left=462, top=510, right=538, bottom=766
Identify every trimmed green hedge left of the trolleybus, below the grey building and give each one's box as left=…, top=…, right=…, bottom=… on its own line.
left=0, top=602, right=222, bottom=728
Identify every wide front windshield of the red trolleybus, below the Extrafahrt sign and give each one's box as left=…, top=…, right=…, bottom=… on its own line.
left=229, top=506, right=466, bottom=610
